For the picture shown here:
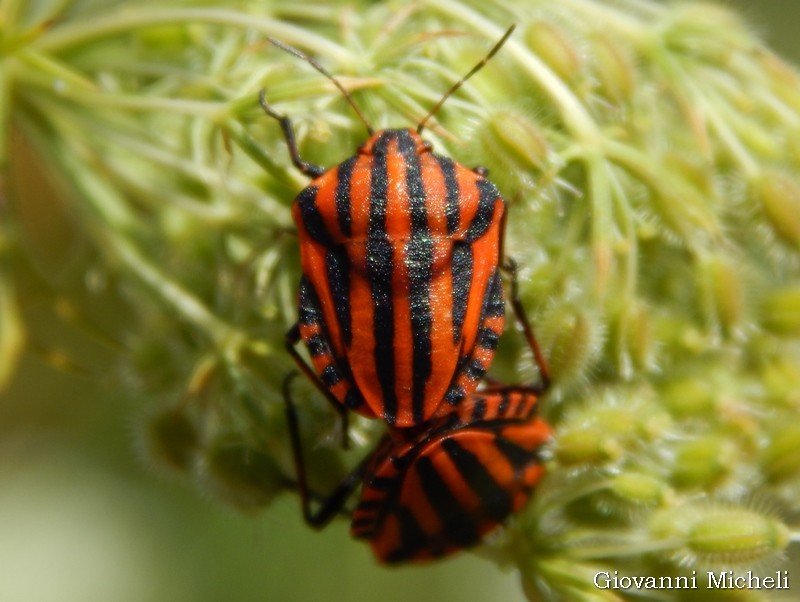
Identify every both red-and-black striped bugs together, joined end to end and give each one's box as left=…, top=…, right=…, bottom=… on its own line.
left=260, top=26, right=550, bottom=563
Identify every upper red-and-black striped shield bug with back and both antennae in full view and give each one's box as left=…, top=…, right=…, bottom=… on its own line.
left=260, top=26, right=514, bottom=426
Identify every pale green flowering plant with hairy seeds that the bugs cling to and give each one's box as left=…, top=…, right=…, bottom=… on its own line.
left=0, top=0, right=800, bottom=600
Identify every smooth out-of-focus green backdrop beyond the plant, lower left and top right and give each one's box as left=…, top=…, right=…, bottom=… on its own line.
left=0, top=0, right=800, bottom=602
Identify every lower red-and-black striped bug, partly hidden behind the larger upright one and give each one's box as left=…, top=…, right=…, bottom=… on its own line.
left=284, top=381, right=551, bottom=564
